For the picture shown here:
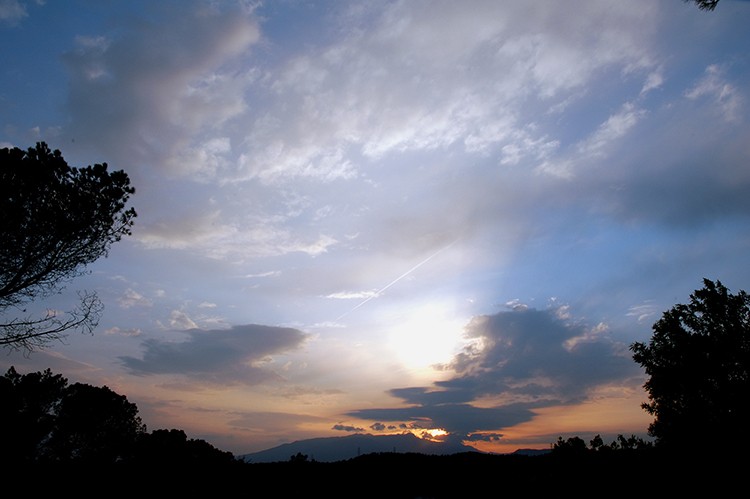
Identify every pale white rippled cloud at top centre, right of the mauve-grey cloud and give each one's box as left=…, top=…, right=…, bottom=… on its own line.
left=234, top=2, right=650, bottom=182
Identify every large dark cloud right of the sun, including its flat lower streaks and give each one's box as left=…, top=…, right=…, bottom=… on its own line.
left=349, top=307, right=639, bottom=435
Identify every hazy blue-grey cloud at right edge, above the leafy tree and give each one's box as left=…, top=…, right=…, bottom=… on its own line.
left=580, top=103, right=750, bottom=230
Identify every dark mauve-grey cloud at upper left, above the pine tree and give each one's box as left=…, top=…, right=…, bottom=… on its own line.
left=64, top=2, right=260, bottom=178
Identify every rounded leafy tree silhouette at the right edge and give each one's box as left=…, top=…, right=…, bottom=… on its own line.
left=630, top=279, right=750, bottom=449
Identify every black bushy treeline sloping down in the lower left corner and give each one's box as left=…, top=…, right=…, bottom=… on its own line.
left=0, top=367, right=236, bottom=469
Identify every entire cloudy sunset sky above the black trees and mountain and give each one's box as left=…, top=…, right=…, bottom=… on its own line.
left=0, top=0, right=750, bottom=455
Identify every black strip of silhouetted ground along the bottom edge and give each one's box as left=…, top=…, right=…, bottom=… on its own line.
left=16, top=448, right=747, bottom=498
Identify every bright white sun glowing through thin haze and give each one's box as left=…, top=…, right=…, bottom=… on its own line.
left=388, top=304, right=465, bottom=369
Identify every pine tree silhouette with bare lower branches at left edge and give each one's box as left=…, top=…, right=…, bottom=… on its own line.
left=0, top=142, right=136, bottom=351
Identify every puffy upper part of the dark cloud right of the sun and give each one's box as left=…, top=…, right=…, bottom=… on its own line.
left=444, top=309, right=638, bottom=402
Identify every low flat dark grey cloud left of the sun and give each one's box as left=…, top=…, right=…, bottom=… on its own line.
left=120, top=324, right=307, bottom=384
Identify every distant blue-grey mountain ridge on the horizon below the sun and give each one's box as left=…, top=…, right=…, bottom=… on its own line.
left=238, top=433, right=479, bottom=463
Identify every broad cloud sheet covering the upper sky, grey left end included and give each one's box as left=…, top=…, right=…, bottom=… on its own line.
left=50, top=1, right=672, bottom=272
